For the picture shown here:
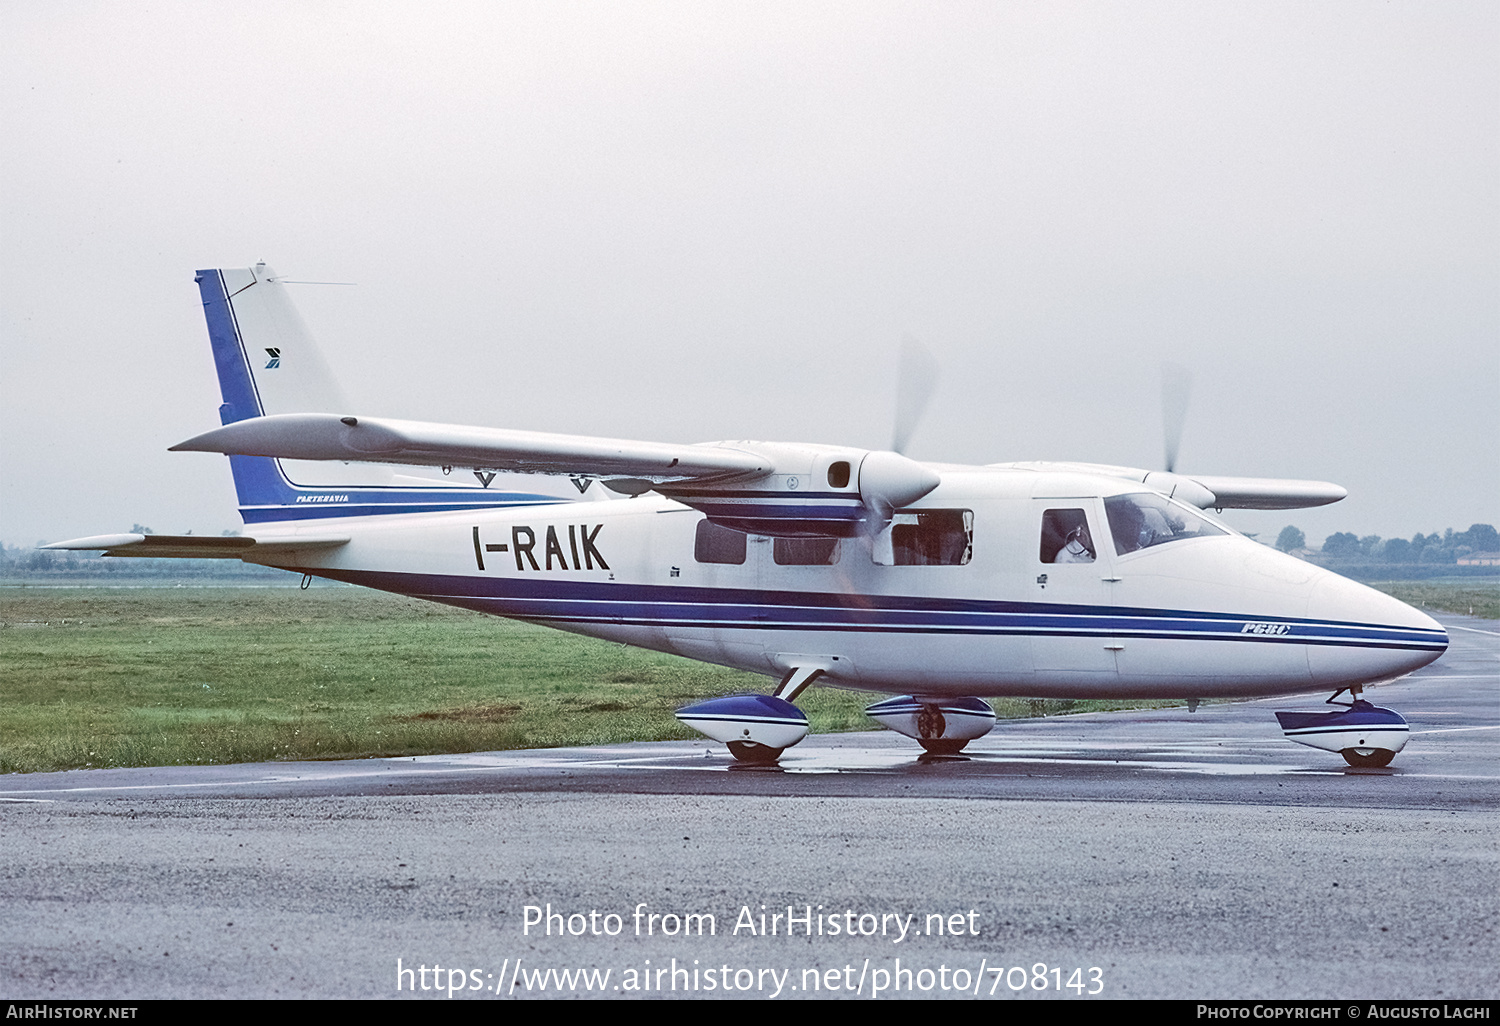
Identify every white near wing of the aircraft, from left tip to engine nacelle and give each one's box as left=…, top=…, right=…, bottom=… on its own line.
left=173, top=414, right=771, bottom=483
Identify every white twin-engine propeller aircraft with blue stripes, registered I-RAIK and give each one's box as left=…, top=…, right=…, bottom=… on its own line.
left=50, top=264, right=1448, bottom=767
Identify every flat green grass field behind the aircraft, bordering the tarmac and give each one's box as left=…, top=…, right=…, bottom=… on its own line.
left=0, top=582, right=1500, bottom=773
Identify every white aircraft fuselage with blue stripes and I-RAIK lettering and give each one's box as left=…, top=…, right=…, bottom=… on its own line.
left=254, top=467, right=1448, bottom=698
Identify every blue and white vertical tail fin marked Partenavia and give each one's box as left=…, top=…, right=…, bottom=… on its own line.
left=194, top=264, right=566, bottom=524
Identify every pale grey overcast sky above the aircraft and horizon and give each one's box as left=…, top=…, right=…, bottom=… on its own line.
left=0, top=0, right=1500, bottom=545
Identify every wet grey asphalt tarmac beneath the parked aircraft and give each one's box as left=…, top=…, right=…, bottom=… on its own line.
left=0, top=615, right=1500, bottom=1001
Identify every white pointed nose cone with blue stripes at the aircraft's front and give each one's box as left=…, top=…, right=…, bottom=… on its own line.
left=1308, top=570, right=1448, bottom=687
